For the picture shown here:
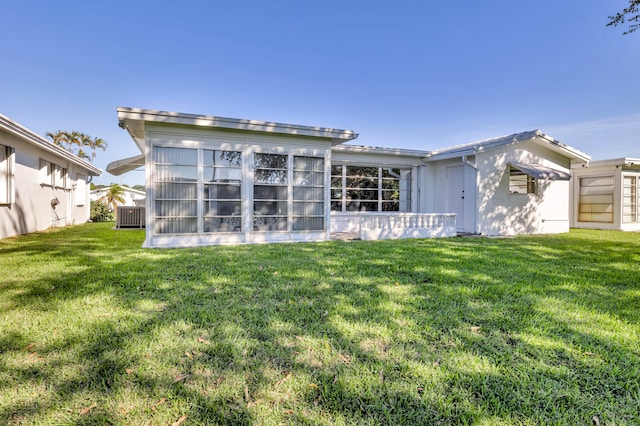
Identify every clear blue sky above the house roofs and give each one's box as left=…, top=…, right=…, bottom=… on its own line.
left=0, top=0, right=640, bottom=185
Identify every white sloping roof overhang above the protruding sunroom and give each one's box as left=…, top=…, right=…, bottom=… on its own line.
left=117, top=107, right=358, bottom=146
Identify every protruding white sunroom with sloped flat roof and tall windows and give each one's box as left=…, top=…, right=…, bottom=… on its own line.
left=108, top=108, right=357, bottom=247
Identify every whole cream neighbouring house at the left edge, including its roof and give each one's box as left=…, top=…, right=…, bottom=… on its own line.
left=0, top=114, right=101, bottom=238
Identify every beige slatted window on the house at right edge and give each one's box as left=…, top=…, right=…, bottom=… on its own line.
left=578, top=176, right=613, bottom=223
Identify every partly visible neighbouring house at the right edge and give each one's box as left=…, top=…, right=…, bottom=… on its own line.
left=571, top=158, right=640, bottom=231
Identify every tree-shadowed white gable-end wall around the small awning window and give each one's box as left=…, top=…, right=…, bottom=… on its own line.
left=475, top=141, right=571, bottom=235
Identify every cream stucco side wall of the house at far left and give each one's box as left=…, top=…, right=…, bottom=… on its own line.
left=0, top=126, right=94, bottom=238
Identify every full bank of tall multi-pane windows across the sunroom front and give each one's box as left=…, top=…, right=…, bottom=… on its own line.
left=153, top=147, right=325, bottom=234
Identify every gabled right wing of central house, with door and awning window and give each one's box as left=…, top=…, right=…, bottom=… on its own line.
left=424, top=130, right=591, bottom=235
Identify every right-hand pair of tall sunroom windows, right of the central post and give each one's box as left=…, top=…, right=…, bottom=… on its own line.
left=253, top=153, right=325, bottom=231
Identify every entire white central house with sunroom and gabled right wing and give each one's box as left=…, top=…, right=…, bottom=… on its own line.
left=107, top=108, right=590, bottom=247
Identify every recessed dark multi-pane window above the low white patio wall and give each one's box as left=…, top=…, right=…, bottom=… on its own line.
left=331, top=164, right=411, bottom=212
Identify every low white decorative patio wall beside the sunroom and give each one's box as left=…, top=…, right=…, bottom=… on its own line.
left=331, top=212, right=456, bottom=240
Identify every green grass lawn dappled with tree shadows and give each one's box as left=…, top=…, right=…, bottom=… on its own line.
left=0, top=223, right=640, bottom=425
